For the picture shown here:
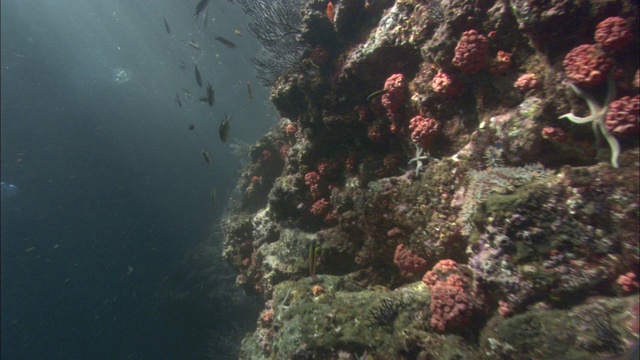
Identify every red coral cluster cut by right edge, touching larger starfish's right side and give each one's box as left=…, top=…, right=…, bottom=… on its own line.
left=604, top=95, right=640, bottom=136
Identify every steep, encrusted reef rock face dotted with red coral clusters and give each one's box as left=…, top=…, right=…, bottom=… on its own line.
left=222, top=0, right=640, bottom=359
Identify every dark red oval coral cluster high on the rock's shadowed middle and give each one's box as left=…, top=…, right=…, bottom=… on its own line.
left=452, top=30, right=489, bottom=74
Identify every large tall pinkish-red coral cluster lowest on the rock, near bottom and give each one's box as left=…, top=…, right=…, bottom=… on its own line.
left=422, top=259, right=472, bottom=332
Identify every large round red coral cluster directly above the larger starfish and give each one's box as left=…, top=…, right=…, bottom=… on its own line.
left=563, top=44, right=613, bottom=87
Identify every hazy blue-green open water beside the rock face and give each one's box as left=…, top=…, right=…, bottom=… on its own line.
left=0, top=0, right=276, bottom=360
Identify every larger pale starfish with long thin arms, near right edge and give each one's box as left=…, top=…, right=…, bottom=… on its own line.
left=559, top=74, right=620, bottom=168
